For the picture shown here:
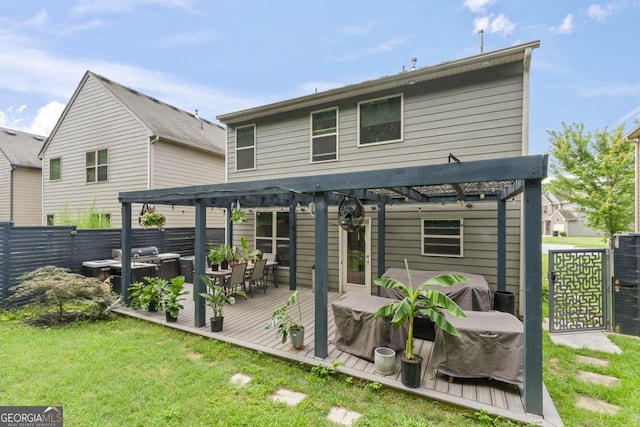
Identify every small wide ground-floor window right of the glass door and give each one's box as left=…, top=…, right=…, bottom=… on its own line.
left=422, top=219, right=463, bottom=257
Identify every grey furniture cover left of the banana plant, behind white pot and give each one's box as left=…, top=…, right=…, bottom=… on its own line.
left=331, top=293, right=408, bottom=361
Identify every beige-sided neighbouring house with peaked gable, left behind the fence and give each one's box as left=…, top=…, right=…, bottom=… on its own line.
left=39, top=71, right=225, bottom=227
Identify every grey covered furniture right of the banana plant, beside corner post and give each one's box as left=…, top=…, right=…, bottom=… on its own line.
left=429, top=311, right=524, bottom=384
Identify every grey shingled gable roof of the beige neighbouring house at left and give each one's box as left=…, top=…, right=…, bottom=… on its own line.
left=40, top=71, right=226, bottom=156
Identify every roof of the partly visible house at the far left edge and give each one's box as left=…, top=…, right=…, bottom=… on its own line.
left=0, top=127, right=45, bottom=169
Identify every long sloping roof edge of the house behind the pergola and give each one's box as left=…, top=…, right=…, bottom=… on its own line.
left=216, top=41, right=540, bottom=125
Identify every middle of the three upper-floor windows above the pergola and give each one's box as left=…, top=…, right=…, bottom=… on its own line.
left=311, top=108, right=338, bottom=163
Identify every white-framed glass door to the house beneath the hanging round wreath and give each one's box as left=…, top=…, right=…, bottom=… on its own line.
left=340, top=218, right=371, bottom=295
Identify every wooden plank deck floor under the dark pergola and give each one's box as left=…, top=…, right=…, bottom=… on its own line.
left=116, top=284, right=562, bottom=426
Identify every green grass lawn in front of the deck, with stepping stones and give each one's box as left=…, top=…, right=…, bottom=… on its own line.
left=0, top=312, right=514, bottom=427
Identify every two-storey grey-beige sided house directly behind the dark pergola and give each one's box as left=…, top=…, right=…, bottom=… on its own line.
left=218, top=42, right=539, bottom=304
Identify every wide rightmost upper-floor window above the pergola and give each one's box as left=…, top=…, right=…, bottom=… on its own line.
left=358, top=94, right=403, bottom=146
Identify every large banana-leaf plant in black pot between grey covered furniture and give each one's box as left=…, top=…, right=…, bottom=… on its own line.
left=374, top=259, right=467, bottom=388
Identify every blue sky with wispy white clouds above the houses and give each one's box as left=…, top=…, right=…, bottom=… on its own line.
left=0, top=0, right=640, bottom=154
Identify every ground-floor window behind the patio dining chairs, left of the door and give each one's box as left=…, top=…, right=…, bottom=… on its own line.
left=256, top=211, right=289, bottom=267
